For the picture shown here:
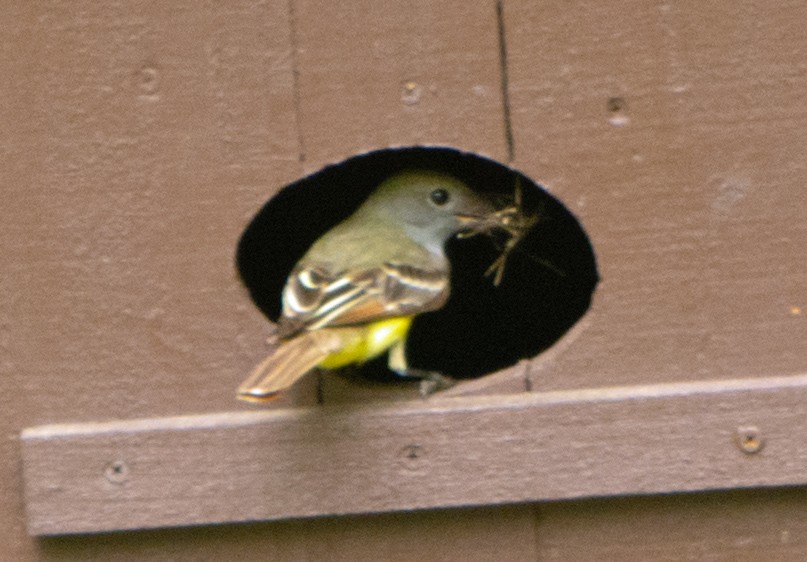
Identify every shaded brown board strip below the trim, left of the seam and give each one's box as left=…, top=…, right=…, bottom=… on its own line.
left=38, top=505, right=537, bottom=562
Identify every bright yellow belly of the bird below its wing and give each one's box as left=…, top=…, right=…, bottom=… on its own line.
left=319, top=316, right=412, bottom=369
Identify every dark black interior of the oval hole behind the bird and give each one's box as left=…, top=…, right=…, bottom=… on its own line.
left=237, top=147, right=598, bottom=379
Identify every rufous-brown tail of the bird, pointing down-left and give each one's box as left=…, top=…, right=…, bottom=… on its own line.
left=238, top=330, right=342, bottom=402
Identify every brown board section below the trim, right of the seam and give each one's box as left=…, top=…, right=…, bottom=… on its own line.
left=535, top=487, right=807, bottom=562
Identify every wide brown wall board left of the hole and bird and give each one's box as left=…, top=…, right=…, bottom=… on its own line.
left=0, top=0, right=301, bottom=561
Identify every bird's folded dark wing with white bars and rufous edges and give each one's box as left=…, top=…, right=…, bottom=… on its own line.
left=278, top=262, right=449, bottom=338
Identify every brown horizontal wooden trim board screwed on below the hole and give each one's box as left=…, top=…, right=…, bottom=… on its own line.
left=22, top=375, right=807, bottom=535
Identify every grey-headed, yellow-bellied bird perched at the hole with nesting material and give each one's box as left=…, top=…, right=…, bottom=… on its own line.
left=238, top=170, right=516, bottom=401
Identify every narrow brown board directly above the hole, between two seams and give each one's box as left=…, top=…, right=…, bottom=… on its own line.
left=292, top=0, right=506, bottom=171
